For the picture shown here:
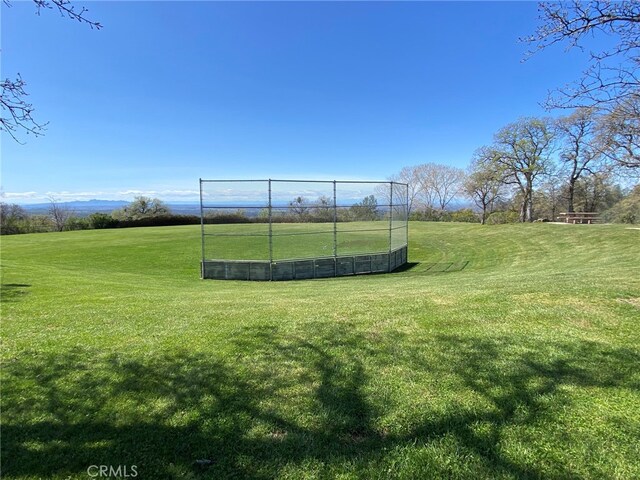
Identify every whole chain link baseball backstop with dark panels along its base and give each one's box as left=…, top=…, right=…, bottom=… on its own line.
left=200, top=179, right=408, bottom=280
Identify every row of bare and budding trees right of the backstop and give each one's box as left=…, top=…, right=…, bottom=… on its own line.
left=390, top=107, right=640, bottom=224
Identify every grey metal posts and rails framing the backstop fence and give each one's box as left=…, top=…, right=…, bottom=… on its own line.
left=199, top=178, right=409, bottom=280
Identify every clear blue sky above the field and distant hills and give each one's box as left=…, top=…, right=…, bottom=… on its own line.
left=1, top=1, right=586, bottom=203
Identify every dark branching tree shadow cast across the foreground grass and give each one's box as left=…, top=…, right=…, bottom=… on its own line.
left=2, top=323, right=640, bottom=479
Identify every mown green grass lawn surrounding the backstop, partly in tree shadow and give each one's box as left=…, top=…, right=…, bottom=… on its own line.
left=1, top=223, right=640, bottom=479
